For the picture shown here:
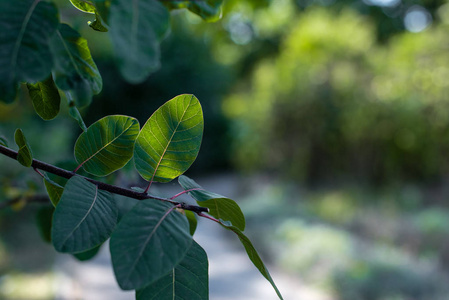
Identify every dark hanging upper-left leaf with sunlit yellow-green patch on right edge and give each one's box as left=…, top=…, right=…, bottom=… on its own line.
left=51, top=24, right=103, bottom=107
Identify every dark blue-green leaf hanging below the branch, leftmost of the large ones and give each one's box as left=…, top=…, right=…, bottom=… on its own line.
left=51, top=176, right=118, bottom=253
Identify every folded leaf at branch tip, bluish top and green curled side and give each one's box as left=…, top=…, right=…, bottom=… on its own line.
left=178, top=175, right=245, bottom=231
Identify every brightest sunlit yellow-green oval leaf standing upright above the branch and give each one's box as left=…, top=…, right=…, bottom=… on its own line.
left=134, top=95, right=204, bottom=182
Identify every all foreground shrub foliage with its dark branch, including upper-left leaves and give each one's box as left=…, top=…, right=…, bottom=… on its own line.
left=0, top=0, right=282, bottom=299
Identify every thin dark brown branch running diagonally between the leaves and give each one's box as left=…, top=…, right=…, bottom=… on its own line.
left=0, top=145, right=209, bottom=213
